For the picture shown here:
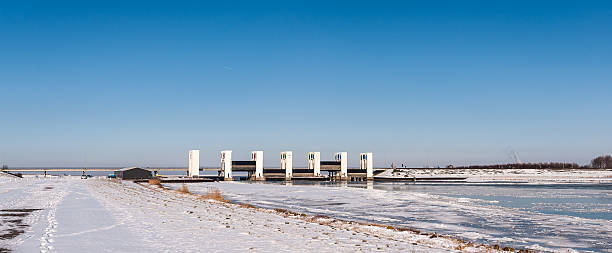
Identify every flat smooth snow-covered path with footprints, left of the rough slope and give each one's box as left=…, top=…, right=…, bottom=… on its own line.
left=0, top=177, right=148, bottom=252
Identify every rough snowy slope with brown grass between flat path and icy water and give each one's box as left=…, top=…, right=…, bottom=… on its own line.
left=94, top=182, right=490, bottom=252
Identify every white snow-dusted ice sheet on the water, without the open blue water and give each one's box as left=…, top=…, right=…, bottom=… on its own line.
left=169, top=182, right=612, bottom=252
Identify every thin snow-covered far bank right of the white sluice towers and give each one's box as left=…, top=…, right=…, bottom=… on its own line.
left=378, top=169, right=612, bottom=183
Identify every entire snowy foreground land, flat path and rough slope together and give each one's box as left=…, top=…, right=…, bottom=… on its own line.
left=0, top=177, right=502, bottom=252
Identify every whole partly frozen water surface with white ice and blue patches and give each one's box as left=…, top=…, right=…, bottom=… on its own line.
left=169, top=175, right=612, bottom=252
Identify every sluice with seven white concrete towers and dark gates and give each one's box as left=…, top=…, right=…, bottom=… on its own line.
left=188, top=150, right=375, bottom=181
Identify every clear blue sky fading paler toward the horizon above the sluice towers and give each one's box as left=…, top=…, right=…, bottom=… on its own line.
left=0, top=1, right=612, bottom=167
